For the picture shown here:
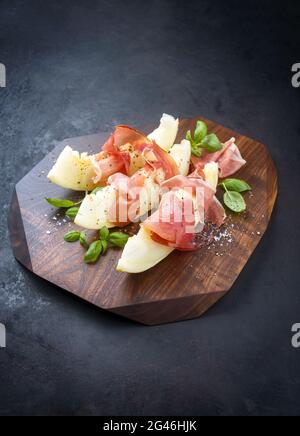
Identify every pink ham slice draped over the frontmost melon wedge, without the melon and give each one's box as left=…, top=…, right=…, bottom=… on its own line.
left=142, top=172, right=225, bottom=251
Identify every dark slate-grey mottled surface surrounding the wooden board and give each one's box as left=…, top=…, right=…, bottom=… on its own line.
left=0, top=0, right=300, bottom=415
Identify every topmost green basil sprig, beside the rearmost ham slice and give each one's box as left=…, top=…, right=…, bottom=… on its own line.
left=186, top=121, right=222, bottom=157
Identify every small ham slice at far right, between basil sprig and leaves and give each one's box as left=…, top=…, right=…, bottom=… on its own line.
left=192, top=138, right=246, bottom=178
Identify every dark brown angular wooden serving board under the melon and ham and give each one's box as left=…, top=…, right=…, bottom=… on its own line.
left=9, top=117, right=277, bottom=325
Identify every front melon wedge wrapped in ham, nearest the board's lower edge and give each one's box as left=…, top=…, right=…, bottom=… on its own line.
left=117, top=162, right=225, bottom=273
